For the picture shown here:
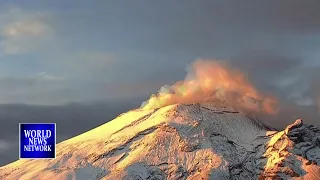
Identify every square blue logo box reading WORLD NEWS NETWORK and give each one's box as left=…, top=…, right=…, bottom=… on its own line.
left=19, top=123, right=56, bottom=159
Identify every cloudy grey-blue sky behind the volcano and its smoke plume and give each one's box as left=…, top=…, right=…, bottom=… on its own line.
left=0, top=0, right=320, bottom=166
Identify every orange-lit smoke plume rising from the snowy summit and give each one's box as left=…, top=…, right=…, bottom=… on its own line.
left=141, top=60, right=277, bottom=114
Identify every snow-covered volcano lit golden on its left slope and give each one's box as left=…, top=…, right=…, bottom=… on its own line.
left=0, top=101, right=320, bottom=180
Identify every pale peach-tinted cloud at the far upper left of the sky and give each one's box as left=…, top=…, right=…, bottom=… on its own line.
left=0, top=9, right=54, bottom=54
